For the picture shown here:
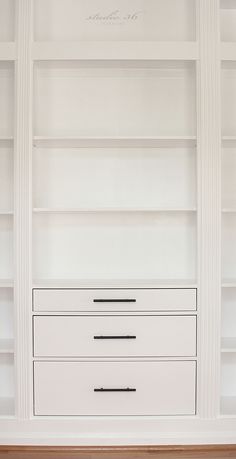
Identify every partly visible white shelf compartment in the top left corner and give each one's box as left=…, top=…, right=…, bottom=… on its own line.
left=0, top=0, right=15, bottom=43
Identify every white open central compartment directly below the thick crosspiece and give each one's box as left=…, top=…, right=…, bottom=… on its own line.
left=34, top=61, right=196, bottom=138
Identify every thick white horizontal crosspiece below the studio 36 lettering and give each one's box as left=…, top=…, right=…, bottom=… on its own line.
left=32, top=41, right=199, bottom=61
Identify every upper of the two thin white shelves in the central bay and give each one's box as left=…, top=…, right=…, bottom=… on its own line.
left=33, top=136, right=197, bottom=148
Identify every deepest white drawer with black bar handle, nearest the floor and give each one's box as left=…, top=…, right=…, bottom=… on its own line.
left=34, top=361, right=196, bottom=416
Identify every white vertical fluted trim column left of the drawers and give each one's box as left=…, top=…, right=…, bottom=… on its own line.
left=14, top=0, right=32, bottom=419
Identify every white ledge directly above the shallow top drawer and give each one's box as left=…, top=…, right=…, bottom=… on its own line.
left=33, top=276, right=197, bottom=288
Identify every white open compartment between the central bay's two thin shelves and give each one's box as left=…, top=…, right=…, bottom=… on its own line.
left=32, top=147, right=196, bottom=209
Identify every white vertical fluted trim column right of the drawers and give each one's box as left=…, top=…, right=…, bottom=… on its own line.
left=197, top=0, right=221, bottom=418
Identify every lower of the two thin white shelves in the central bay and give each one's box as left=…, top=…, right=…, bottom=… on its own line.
left=33, top=207, right=196, bottom=214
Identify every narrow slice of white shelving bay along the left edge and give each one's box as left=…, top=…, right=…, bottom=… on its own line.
left=0, top=0, right=15, bottom=418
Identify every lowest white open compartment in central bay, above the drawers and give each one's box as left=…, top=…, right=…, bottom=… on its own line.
left=33, top=212, right=196, bottom=279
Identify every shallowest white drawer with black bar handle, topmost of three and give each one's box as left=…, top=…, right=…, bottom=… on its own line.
left=33, top=288, right=197, bottom=312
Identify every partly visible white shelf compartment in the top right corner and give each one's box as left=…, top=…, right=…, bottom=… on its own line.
left=221, top=0, right=236, bottom=42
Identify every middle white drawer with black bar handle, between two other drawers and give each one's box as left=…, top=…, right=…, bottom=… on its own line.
left=34, top=316, right=196, bottom=357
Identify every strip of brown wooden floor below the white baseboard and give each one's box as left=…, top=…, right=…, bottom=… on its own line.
left=0, top=445, right=236, bottom=459
